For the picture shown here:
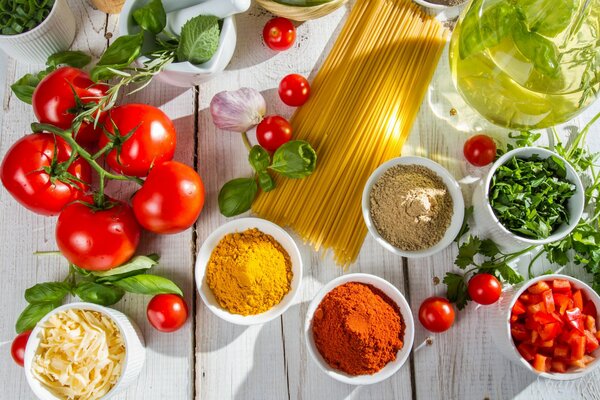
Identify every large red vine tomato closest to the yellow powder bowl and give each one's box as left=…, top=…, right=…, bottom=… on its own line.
left=132, top=161, right=204, bottom=233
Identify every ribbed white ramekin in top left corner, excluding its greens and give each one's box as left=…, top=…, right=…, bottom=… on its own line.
left=0, top=0, right=77, bottom=64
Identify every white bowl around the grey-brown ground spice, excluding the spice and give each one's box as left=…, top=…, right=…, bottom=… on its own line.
left=362, top=156, right=465, bottom=258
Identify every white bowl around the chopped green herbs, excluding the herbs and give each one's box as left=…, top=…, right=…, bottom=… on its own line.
left=473, top=147, right=585, bottom=252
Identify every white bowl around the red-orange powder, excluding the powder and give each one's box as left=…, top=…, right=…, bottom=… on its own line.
left=304, top=274, right=415, bottom=385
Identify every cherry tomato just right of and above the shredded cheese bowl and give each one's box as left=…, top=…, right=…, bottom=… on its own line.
left=146, top=294, right=188, bottom=332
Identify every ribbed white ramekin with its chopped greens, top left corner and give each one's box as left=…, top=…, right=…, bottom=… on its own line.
left=0, top=0, right=77, bottom=64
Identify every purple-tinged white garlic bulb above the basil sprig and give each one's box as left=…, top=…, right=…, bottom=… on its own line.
left=210, top=88, right=267, bottom=133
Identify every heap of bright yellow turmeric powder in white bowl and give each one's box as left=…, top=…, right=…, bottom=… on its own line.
left=206, top=228, right=293, bottom=315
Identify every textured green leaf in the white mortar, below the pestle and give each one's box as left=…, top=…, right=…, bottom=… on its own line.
left=177, top=15, right=221, bottom=65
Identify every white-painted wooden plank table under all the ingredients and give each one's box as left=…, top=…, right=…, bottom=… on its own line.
left=0, top=0, right=600, bottom=400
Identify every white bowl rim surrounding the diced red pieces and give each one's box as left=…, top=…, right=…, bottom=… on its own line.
left=505, top=274, right=600, bottom=380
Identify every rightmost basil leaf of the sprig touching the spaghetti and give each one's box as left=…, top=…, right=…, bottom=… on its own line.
left=269, top=140, right=317, bottom=179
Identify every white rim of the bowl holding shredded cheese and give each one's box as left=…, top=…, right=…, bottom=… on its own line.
left=24, top=301, right=131, bottom=400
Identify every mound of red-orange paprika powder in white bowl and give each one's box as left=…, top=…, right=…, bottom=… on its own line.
left=312, top=282, right=405, bottom=375
